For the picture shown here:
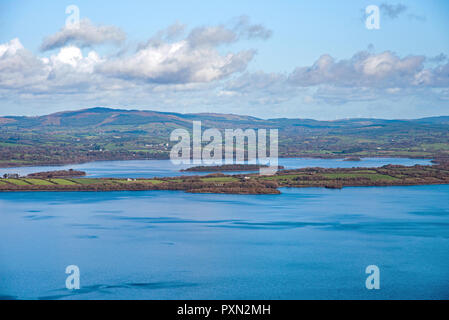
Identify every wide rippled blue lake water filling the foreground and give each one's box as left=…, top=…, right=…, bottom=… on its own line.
left=0, top=159, right=449, bottom=299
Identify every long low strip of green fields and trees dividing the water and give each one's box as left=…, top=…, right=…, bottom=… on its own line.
left=0, top=163, right=449, bottom=194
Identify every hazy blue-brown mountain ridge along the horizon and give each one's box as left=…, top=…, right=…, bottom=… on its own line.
left=0, top=108, right=449, bottom=129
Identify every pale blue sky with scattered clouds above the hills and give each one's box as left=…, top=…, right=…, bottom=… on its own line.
left=0, top=0, right=449, bottom=119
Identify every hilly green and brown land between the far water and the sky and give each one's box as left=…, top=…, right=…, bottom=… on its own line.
left=0, top=108, right=449, bottom=167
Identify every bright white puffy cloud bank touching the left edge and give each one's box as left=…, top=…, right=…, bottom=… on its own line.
left=0, top=39, right=118, bottom=95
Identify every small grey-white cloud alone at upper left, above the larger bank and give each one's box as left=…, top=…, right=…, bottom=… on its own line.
left=41, top=19, right=126, bottom=51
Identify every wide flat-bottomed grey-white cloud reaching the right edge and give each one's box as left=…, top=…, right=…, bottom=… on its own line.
left=289, top=51, right=449, bottom=88
